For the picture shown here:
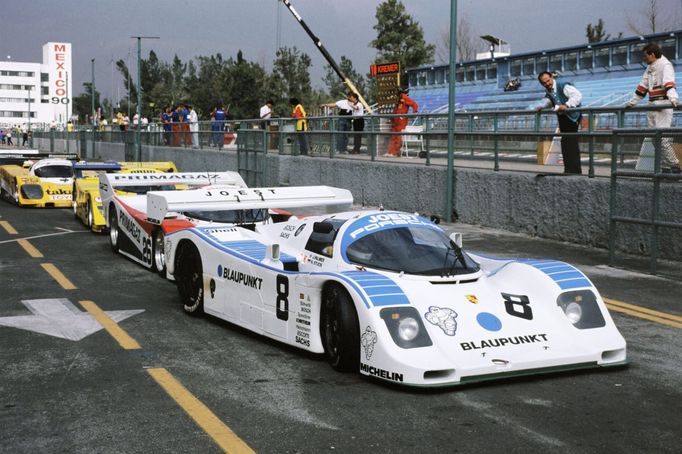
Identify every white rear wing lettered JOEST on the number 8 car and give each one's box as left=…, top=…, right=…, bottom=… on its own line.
left=147, top=186, right=353, bottom=224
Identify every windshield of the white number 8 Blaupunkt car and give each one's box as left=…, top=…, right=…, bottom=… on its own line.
left=346, top=227, right=479, bottom=276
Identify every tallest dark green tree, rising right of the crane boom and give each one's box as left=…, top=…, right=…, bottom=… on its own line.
left=371, top=0, right=436, bottom=71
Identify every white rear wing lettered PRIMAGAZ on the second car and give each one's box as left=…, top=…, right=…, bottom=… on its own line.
left=99, top=172, right=246, bottom=204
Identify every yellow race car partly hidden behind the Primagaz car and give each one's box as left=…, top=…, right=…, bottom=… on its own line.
left=72, top=161, right=177, bottom=232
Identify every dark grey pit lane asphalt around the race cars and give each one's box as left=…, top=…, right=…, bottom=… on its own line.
left=0, top=201, right=682, bottom=453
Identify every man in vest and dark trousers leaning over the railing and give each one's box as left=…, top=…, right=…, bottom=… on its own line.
left=537, top=71, right=582, bottom=174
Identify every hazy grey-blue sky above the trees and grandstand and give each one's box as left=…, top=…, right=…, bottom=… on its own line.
left=0, top=0, right=682, bottom=100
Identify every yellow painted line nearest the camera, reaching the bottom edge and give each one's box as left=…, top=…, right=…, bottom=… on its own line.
left=147, top=368, right=255, bottom=454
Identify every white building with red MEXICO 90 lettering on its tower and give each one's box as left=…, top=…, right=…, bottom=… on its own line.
left=0, top=42, right=73, bottom=128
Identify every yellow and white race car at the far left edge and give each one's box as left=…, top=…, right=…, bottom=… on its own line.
left=0, top=158, right=73, bottom=208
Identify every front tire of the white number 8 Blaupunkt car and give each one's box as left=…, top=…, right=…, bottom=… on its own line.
left=320, top=285, right=360, bottom=372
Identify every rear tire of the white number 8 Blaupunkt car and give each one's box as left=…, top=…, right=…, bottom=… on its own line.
left=174, top=243, right=204, bottom=315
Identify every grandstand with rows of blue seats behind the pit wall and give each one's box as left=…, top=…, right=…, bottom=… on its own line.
left=407, top=30, right=682, bottom=113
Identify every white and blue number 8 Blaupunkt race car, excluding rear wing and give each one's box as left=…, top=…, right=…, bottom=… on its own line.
left=166, top=204, right=627, bottom=386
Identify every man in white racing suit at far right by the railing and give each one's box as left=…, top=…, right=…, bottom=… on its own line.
left=625, top=43, right=680, bottom=173
